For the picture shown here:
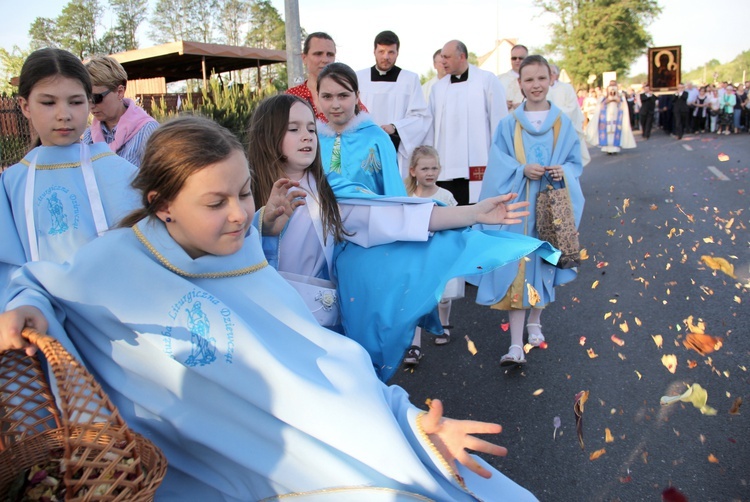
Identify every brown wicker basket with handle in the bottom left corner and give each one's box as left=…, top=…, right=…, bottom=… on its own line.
left=0, top=328, right=167, bottom=501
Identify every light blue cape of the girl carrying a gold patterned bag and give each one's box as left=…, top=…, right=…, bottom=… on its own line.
left=477, top=103, right=584, bottom=308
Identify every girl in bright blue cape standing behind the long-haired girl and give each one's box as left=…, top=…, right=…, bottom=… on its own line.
left=318, top=63, right=406, bottom=196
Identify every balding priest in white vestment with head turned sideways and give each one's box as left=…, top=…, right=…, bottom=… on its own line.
left=425, top=40, right=508, bottom=204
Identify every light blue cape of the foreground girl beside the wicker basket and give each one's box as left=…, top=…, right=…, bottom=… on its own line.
left=9, top=219, right=535, bottom=502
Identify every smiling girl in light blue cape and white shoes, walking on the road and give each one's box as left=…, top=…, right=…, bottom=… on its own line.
left=477, top=56, right=584, bottom=366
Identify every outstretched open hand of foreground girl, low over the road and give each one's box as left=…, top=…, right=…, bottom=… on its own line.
left=421, top=399, right=508, bottom=478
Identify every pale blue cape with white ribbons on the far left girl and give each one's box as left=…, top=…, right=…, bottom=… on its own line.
left=0, top=143, right=140, bottom=294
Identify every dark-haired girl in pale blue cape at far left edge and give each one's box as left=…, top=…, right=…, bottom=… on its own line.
left=0, top=48, right=138, bottom=294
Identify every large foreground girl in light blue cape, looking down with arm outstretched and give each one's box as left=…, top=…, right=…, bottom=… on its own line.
left=0, top=117, right=535, bottom=502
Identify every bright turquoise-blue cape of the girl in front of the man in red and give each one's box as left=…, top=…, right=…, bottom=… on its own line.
left=318, top=113, right=406, bottom=197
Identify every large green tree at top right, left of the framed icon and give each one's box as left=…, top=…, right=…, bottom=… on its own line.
left=534, top=0, right=661, bottom=84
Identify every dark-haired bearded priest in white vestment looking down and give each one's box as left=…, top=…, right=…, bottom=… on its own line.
left=357, top=31, right=432, bottom=178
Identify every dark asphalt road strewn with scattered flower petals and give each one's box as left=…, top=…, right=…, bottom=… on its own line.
left=391, top=127, right=750, bottom=501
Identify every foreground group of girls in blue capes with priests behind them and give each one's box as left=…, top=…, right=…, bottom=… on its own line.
left=0, top=31, right=592, bottom=501
